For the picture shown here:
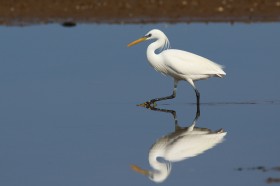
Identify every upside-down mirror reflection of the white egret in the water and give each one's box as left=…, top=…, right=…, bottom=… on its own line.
left=131, top=107, right=226, bottom=182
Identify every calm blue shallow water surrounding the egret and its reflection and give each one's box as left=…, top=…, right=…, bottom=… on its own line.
left=0, top=23, right=280, bottom=186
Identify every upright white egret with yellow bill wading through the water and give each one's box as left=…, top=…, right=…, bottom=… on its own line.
left=127, top=29, right=226, bottom=112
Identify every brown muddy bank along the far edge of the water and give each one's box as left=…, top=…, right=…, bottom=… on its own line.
left=0, top=0, right=280, bottom=26
